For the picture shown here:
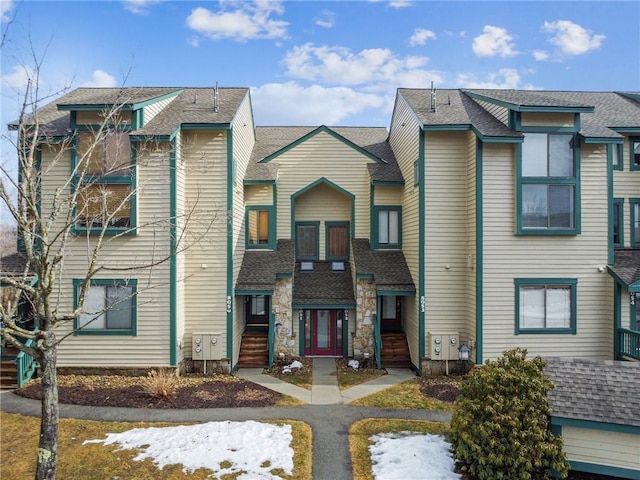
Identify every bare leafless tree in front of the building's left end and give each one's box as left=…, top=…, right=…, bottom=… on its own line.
left=0, top=64, right=217, bottom=479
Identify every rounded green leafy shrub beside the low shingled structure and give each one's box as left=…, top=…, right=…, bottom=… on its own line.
left=451, top=349, right=569, bottom=480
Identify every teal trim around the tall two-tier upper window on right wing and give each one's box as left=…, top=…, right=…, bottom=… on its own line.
left=516, top=129, right=582, bottom=235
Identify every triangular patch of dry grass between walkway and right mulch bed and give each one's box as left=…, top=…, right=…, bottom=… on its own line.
left=350, top=378, right=453, bottom=411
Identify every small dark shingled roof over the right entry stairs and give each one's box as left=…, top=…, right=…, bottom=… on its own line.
left=352, top=238, right=416, bottom=293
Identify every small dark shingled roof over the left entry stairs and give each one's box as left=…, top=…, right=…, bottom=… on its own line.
left=236, top=240, right=294, bottom=291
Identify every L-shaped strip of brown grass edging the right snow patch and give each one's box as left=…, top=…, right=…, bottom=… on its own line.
left=349, top=418, right=451, bottom=480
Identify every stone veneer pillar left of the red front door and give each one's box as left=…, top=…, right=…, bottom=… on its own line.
left=272, top=278, right=300, bottom=358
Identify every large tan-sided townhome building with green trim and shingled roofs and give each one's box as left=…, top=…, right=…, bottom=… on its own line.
left=4, top=87, right=640, bottom=375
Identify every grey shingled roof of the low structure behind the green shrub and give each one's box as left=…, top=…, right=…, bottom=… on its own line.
left=544, top=357, right=640, bottom=428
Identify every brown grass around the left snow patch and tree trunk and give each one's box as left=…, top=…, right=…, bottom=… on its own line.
left=0, top=412, right=312, bottom=480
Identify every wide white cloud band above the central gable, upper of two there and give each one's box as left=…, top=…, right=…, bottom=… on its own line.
left=284, top=43, right=442, bottom=90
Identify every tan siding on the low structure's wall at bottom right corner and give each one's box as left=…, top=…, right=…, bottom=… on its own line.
left=562, top=427, right=640, bottom=472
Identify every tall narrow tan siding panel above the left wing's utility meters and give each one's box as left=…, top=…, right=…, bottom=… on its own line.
left=182, top=130, right=228, bottom=354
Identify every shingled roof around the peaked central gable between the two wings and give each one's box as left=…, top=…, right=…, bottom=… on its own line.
left=245, top=126, right=403, bottom=182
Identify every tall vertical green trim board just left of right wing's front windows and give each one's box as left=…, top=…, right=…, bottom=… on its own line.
left=475, top=138, right=484, bottom=365
